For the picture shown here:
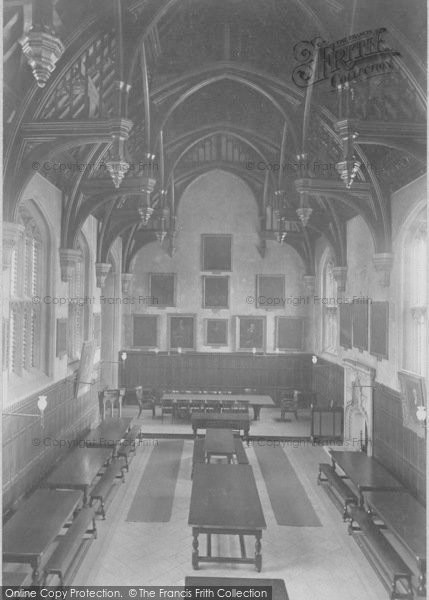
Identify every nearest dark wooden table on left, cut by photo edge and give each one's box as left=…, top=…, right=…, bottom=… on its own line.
left=3, top=489, right=82, bottom=584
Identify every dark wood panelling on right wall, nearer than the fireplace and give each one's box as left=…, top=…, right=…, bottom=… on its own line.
left=374, top=384, right=426, bottom=503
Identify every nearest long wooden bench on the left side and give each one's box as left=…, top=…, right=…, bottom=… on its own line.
left=44, top=507, right=97, bottom=586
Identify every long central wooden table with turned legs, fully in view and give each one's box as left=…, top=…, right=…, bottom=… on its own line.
left=188, top=464, right=266, bottom=571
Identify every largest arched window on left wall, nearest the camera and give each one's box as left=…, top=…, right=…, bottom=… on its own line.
left=8, top=205, right=47, bottom=377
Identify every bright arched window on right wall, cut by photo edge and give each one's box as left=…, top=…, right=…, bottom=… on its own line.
left=402, top=210, right=428, bottom=376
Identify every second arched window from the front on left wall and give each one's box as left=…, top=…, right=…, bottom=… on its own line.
left=67, top=235, right=88, bottom=362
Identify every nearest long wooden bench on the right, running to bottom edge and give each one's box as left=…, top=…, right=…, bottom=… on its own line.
left=348, top=506, right=413, bottom=600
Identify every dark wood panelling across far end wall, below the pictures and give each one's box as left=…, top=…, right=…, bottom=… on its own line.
left=121, top=350, right=311, bottom=393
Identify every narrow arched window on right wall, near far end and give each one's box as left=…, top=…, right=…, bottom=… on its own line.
left=322, top=256, right=338, bottom=354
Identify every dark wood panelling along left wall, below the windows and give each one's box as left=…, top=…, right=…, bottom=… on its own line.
left=2, top=378, right=98, bottom=511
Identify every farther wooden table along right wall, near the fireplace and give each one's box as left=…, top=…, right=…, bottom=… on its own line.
left=330, top=450, right=404, bottom=506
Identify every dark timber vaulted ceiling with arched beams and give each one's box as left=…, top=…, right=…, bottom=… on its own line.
left=4, top=0, right=426, bottom=273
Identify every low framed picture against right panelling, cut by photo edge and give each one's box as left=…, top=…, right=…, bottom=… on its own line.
left=398, top=371, right=427, bottom=437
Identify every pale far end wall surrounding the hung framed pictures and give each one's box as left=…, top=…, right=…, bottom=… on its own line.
left=124, top=170, right=308, bottom=352
